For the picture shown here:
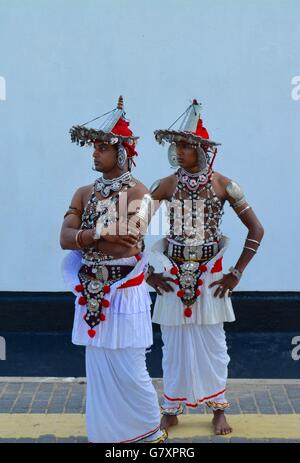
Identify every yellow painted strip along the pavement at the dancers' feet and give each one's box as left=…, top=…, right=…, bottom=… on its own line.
left=0, top=413, right=300, bottom=439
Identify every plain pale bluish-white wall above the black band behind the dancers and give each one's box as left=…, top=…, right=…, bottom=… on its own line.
left=0, top=0, right=300, bottom=291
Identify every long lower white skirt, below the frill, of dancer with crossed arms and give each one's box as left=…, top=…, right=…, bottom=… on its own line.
left=86, top=346, right=161, bottom=443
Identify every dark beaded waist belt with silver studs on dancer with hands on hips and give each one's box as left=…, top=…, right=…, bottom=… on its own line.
left=167, top=242, right=219, bottom=262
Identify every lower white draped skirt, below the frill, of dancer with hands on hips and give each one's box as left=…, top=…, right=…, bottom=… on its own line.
left=161, top=323, right=230, bottom=411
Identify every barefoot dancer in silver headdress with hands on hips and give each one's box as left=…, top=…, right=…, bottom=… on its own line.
left=147, top=100, right=264, bottom=434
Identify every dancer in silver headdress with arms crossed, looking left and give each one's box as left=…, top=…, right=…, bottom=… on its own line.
left=60, top=97, right=166, bottom=443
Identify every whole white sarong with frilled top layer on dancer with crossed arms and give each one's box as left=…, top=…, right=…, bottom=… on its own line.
left=63, top=251, right=162, bottom=443
